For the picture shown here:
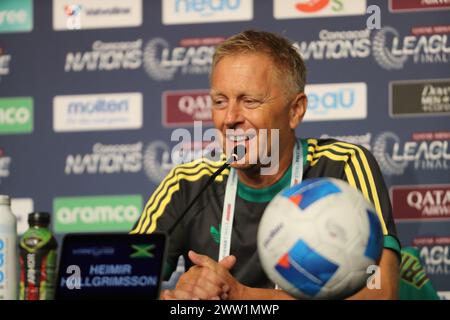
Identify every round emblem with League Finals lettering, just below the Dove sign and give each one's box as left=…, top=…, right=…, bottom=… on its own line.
left=372, top=132, right=450, bottom=175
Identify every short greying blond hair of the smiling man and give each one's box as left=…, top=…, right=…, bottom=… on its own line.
left=212, top=30, right=306, bottom=93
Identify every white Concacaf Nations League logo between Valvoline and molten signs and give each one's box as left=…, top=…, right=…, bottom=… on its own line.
left=64, top=37, right=224, bottom=81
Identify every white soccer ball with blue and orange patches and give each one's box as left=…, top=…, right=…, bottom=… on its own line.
left=257, top=178, right=383, bottom=299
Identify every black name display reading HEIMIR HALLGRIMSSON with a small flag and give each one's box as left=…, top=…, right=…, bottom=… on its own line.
left=55, top=233, right=167, bottom=300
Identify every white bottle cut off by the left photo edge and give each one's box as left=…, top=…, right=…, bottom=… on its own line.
left=0, top=195, right=18, bottom=300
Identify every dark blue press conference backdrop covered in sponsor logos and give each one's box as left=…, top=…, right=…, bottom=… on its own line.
left=0, top=0, right=450, bottom=297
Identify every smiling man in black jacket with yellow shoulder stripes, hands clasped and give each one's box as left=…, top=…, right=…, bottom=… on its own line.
left=131, top=30, right=400, bottom=299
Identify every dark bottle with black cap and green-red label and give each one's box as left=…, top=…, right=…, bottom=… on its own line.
left=19, top=212, right=58, bottom=300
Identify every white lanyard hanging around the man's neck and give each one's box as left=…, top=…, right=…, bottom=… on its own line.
left=219, top=139, right=303, bottom=261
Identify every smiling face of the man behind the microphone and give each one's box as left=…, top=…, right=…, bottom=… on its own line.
left=211, top=53, right=293, bottom=169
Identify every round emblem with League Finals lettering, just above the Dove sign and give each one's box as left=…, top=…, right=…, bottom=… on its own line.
left=373, top=26, right=450, bottom=70
